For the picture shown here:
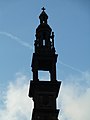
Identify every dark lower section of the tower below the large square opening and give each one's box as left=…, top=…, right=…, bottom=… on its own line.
left=29, top=81, right=61, bottom=120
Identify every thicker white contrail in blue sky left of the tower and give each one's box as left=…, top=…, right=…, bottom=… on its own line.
left=0, top=32, right=33, bottom=49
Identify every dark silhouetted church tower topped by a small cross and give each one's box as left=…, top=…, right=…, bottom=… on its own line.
left=29, top=8, right=61, bottom=120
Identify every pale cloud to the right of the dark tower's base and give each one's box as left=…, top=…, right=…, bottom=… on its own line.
left=59, top=72, right=90, bottom=120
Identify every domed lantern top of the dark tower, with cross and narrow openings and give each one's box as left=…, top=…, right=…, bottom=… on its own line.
left=35, top=8, right=55, bottom=54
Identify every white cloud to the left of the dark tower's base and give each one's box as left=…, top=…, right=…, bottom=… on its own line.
left=0, top=74, right=33, bottom=120
